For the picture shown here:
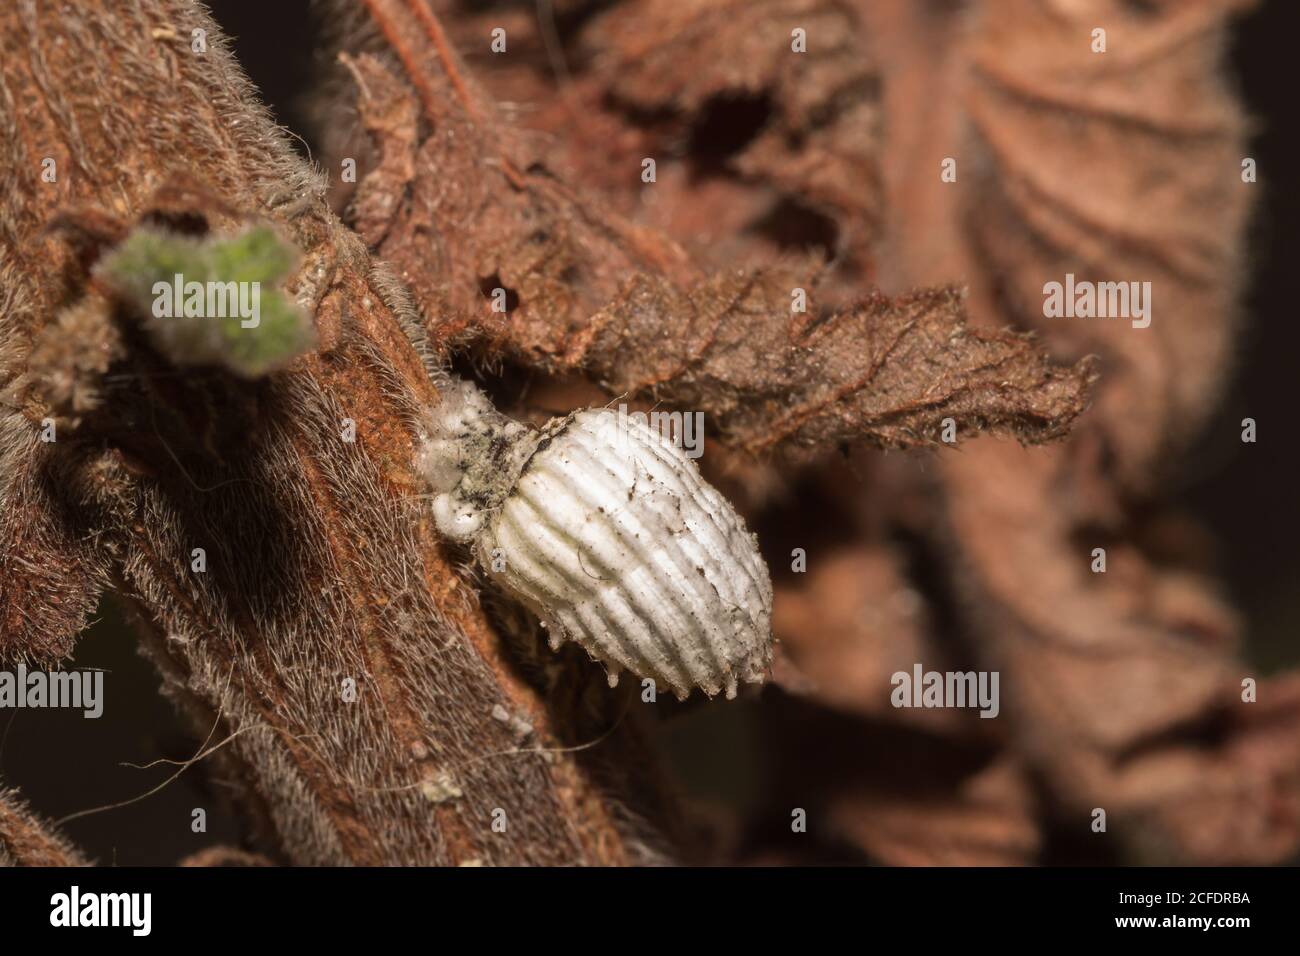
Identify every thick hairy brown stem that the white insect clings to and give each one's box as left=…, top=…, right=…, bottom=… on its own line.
left=0, top=0, right=681, bottom=864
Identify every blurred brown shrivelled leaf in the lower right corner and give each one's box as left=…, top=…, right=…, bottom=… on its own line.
left=944, top=442, right=1300, bottom=865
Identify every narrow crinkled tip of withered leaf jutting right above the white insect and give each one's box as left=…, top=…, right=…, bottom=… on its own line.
left=563, top=276, right=1093, bottom=453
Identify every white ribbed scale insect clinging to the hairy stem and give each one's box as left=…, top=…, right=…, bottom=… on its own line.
left=417, top=381, right=772, bottom=698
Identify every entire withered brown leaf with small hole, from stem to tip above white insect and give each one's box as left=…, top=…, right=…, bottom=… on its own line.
left=327, top=10, right=1093, bottom=460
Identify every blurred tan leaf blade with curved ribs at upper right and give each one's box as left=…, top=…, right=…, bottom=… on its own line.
left=963, top=0, right=1257, bottom=486
